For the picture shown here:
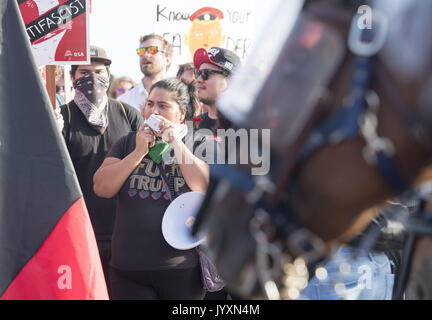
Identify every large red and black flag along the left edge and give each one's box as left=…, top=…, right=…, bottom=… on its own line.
left=0, top=0, right=108, bottom=299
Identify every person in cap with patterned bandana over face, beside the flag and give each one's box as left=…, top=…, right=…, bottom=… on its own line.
left=60, top=46, right=142, bottom=292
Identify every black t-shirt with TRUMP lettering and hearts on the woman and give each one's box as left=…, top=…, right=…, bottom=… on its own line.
left=107, top=132, right=207, bottom=271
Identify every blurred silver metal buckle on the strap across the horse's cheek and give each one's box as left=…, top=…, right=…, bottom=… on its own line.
left=359, top=90, right=395, bottom=165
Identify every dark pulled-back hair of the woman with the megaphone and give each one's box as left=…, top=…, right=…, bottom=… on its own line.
left=149, top=78, right=201, bottom=125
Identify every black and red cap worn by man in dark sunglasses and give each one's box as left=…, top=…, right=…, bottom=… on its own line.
left=194, top=47, right=240, bottom=73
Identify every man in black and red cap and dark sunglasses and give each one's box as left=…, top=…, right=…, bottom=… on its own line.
left=194, top=47, right=240, bottom=129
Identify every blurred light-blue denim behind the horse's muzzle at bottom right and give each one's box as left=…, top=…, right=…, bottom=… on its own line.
left=301, top=247, right=394, bottom=300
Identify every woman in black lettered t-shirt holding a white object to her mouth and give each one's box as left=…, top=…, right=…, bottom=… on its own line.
left=94, top=78, right=209, bottom=300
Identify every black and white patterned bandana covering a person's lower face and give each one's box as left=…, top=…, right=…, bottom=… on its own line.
left=73, top=73, right=109, bottom=133
